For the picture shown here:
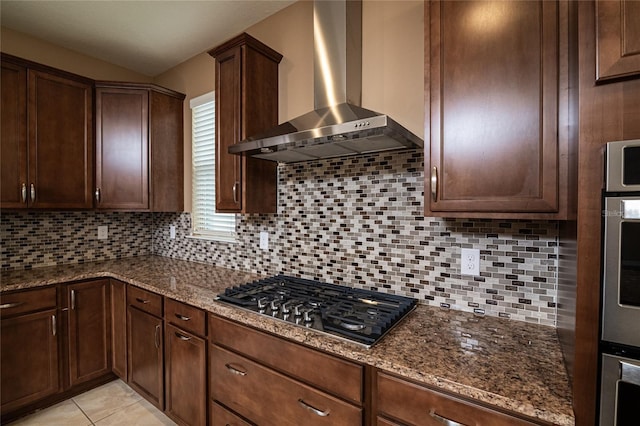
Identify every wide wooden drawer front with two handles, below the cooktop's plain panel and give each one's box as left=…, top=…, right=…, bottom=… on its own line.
left=210, top=345, right=362, bottom=426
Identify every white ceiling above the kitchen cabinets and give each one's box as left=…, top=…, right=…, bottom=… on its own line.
left=0, top=0, right=295, bottom=77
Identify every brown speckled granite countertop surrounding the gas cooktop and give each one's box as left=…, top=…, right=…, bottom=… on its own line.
left=0, top=256, right=575, bottom=426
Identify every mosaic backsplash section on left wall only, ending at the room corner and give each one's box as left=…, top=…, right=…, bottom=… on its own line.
left=0, top=211, right=152, bottom=270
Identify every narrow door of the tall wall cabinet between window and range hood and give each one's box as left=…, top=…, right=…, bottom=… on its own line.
left=216, top=47, right=242, bottom=212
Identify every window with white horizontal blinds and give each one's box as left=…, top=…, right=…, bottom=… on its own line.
left=190, top=92, right=236, bottom=241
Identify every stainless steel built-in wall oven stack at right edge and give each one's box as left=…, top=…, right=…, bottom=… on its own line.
left=600, top=140, right=640, bottom=426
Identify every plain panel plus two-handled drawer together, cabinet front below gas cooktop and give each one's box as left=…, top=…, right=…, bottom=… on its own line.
left=209, top=316, right=364, bottom=425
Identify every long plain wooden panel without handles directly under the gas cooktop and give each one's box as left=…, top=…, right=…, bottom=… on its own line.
left=209, top=315, right=363, bottom=404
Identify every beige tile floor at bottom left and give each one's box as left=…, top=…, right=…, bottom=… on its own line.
left=11, top=380, right=175, bottom=426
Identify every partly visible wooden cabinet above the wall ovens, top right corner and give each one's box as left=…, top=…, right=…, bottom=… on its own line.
left=595, top=0, right=640, bottom=82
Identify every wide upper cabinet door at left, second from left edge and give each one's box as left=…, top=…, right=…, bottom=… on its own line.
left=27, top=70, right=93, bottom=208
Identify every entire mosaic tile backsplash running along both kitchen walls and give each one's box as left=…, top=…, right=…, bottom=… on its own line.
left=0, top=150, right=558, bottom=326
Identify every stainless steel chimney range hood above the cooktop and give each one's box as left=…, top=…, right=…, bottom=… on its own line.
left=229, top=0, right=424, bottom=163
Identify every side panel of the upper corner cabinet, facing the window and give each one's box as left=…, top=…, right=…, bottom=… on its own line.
left=149, top=91, right=184, bottom=212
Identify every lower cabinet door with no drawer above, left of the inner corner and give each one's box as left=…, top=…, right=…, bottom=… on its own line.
left=67, top=279, right=111, bottom=386
